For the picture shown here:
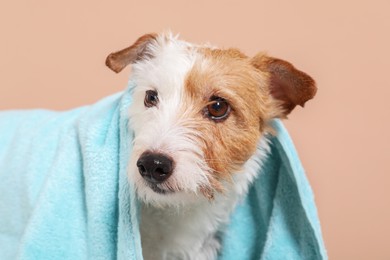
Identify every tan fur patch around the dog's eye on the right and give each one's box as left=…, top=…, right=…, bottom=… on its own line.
left=184, top=49, right=276, bottom=190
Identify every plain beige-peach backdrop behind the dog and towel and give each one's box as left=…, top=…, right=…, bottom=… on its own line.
left=0, top=0, right=390, bottom=259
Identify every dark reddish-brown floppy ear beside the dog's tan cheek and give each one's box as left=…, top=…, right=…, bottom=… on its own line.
left=252, top=53, right=317, bottom=115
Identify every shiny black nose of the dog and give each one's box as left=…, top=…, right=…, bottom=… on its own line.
left=137, top=152, right=173, bottom=184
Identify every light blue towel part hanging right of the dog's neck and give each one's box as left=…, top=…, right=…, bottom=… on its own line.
left=220, top=120, right=327, bottom=260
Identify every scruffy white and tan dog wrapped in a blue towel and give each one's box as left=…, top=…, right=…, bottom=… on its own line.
left=106, top=33, right=316, bottom=260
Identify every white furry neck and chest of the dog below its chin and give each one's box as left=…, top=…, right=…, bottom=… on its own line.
left=141, top=138, right=269, bottom=260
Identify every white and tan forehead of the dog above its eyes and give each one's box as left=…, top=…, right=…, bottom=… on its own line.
left=133, top=37, right=265, bottom=107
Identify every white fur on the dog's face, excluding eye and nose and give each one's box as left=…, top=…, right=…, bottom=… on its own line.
left=129, top=35, right=212, bottom=205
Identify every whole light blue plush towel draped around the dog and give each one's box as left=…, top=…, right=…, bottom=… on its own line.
left=0, top=80, right=326, bottom=260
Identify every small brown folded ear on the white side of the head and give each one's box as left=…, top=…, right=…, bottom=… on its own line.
left=106, top=33, right=157, bottom=73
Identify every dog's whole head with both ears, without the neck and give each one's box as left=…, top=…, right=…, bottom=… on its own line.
left=107, top=34, right=316, bottom=205
